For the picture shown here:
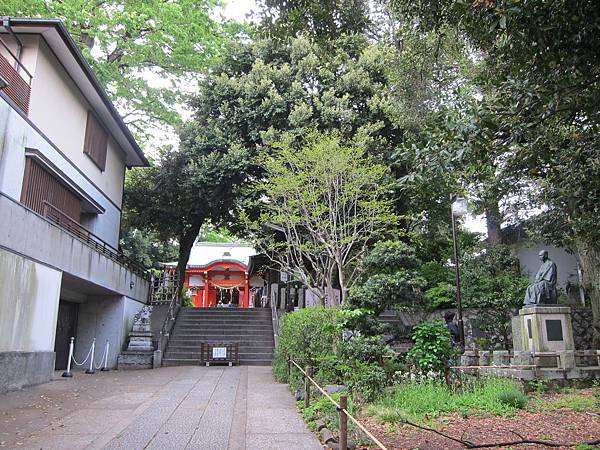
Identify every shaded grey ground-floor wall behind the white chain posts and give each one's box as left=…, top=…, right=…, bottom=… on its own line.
left=75, top=296, right=144, bottom=368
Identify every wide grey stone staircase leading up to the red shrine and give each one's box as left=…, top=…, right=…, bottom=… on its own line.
left=162, top=308, right=275, bottom=366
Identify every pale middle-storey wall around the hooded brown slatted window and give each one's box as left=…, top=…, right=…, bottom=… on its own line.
left=0, top=98, right=123, bottom=247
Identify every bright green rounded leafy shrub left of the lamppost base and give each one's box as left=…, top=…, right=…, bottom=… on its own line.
left=406, top=320, right=456, bottom=373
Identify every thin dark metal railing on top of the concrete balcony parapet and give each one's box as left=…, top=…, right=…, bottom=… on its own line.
left=43, top=202, right=148, bottom=279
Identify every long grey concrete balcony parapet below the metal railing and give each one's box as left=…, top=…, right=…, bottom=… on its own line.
left=0, top=192, right=149, bottom=302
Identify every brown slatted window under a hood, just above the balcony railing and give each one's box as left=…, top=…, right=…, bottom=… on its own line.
left=21, top=158, right=81, bottom=223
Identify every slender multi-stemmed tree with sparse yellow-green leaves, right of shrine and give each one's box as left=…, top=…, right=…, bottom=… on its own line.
left=252, top=133, right=397, bottom=301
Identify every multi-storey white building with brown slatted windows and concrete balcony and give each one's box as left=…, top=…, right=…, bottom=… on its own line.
left=0, top=18, right=148, bottom=391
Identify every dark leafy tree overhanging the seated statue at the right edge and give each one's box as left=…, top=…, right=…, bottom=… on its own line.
left=392, top=0, right=600, bottom=345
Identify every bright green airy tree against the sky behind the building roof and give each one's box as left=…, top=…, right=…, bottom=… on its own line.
left=0, top=0, right=240, bottom=136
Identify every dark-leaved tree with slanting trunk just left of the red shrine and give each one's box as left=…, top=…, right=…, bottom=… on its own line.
left=125, top=144, right=248, bottom=287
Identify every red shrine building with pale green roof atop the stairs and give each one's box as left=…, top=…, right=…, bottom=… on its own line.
left=169, top=242, right=264, bottom=308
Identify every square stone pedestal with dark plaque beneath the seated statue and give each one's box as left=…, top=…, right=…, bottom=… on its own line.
left=512, top=305, right=575, bottom=353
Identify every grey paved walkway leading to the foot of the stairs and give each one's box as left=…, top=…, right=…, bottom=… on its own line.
left=0, top=367, right=322, bottom=450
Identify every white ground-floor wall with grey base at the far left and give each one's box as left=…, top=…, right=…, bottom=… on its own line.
left=0, top=248, right=61, bottom=392
